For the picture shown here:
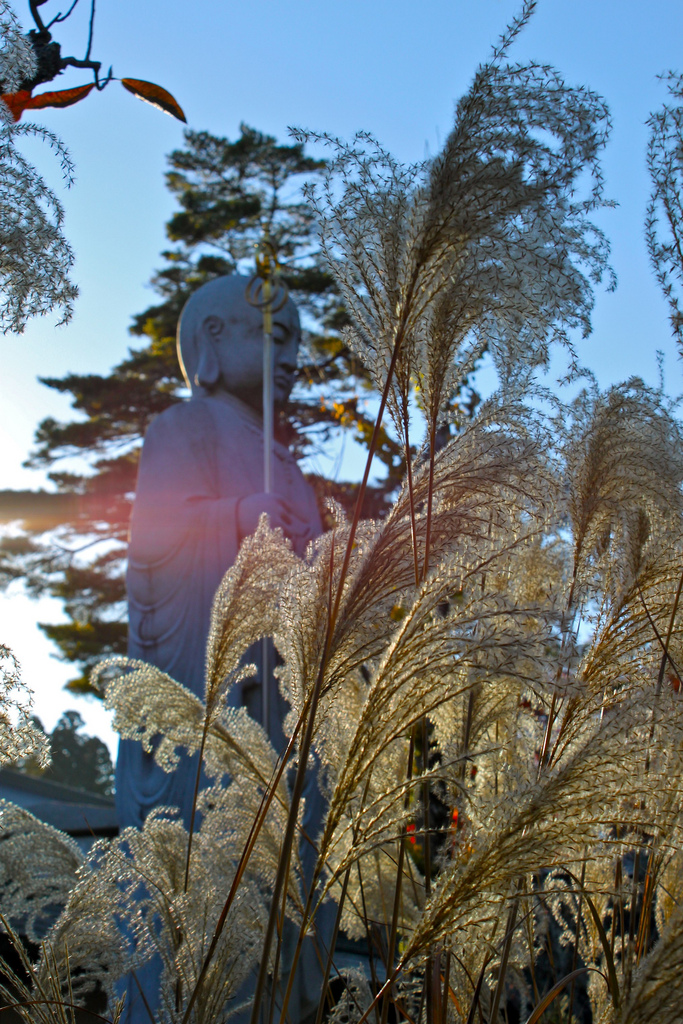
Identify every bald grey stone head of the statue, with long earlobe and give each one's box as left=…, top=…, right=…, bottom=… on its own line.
left=178, top=273, right=301, bottom=410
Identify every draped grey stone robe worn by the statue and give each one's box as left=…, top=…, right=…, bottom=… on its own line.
left=116, top=393, right=325, bottom=1024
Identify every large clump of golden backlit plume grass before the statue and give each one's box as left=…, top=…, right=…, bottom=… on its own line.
left=0, top=3, right=683, bottom=1024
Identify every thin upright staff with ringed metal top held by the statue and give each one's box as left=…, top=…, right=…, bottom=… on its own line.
left=246, top=225, right=289, bottom=735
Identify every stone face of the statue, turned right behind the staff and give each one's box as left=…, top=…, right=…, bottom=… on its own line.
left=214, top=292, right=301, bottom=410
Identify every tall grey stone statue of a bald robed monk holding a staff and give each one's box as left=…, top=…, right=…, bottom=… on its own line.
left=116, top=274, right=322, bottom=827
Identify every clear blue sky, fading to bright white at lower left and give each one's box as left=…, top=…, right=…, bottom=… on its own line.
left=0, top=0, right=683, bottom=757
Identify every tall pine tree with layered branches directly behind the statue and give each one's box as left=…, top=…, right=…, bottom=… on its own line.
left=0, top=125, right=417, bottom=691
